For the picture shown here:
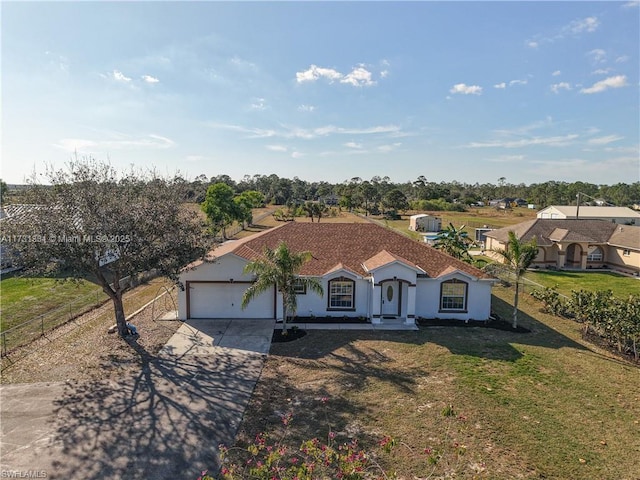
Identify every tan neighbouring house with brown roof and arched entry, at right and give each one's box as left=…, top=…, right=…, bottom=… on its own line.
left=485, top=219, right=640, bottom=275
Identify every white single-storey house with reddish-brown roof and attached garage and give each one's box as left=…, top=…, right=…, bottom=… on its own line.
left=178, top=222, right=495, bottom=323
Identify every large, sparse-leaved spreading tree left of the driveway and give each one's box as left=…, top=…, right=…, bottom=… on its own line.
left=3, top=159, right=209, bottom=336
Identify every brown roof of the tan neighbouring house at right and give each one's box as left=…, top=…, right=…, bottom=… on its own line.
left=486, top=218, right=640, bottom=247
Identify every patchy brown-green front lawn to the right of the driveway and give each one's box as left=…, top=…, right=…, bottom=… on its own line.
left=239, top=287, right=640, bottom=480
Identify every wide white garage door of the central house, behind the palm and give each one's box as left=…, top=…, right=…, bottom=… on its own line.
left=189, top=282, right=274, bottom=318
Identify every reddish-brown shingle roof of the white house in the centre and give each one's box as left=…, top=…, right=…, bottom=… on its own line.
left=200, top=222, right=492, bottom=279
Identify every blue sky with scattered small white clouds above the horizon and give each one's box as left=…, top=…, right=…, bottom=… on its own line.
left=1, top=2, right=640, bottom=184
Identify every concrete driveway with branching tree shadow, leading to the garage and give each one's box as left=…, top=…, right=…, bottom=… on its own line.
left=0, top=320, right=273, bottom=480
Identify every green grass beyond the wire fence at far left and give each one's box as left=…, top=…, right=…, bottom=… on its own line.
left=0, top=276, right=107, bottom=331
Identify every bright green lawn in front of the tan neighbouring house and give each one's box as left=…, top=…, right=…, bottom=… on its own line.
left=525, top=271, right=640, bottom=298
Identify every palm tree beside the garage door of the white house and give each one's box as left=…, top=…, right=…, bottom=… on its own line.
left=242, top=242, right=324, bottom=333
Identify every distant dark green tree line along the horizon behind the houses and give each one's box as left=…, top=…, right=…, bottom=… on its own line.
left=183, top=174, right=640, bottom=212
